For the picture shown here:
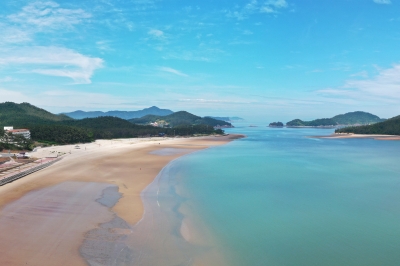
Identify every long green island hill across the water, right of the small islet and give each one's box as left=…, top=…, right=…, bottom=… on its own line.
left=286, top=111, right=385, bottom=127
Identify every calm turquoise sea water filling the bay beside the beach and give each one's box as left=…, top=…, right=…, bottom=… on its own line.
left=167, top=127, right=400, bottom=265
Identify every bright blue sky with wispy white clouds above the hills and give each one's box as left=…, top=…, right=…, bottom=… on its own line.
left=0, top=0, right=400, bottom=122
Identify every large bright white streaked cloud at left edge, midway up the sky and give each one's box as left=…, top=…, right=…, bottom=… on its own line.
left=0, top=46, right=103, bottom=84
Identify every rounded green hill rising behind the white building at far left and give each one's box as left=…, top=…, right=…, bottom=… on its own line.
left=0, top=102, right=73, bottom=128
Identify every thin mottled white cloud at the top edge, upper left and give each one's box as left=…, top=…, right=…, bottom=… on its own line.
left=7, top=1, right=91, bottom=30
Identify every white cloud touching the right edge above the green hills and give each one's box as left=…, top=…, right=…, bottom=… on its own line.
left=319, top=64, right=400, bottom=101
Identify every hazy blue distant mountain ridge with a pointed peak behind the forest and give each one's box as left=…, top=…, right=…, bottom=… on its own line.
left=64, top=106, right=173, bottom=119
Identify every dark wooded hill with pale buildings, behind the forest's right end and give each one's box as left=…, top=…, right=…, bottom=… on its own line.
left=129, top=111, right=232, bottom=127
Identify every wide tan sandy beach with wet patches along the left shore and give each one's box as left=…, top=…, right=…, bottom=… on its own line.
left=0, top=135, right=241, bottom=265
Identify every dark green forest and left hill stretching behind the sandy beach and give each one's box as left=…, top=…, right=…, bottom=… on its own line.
left=0, top=102, right=223, bottom=149
